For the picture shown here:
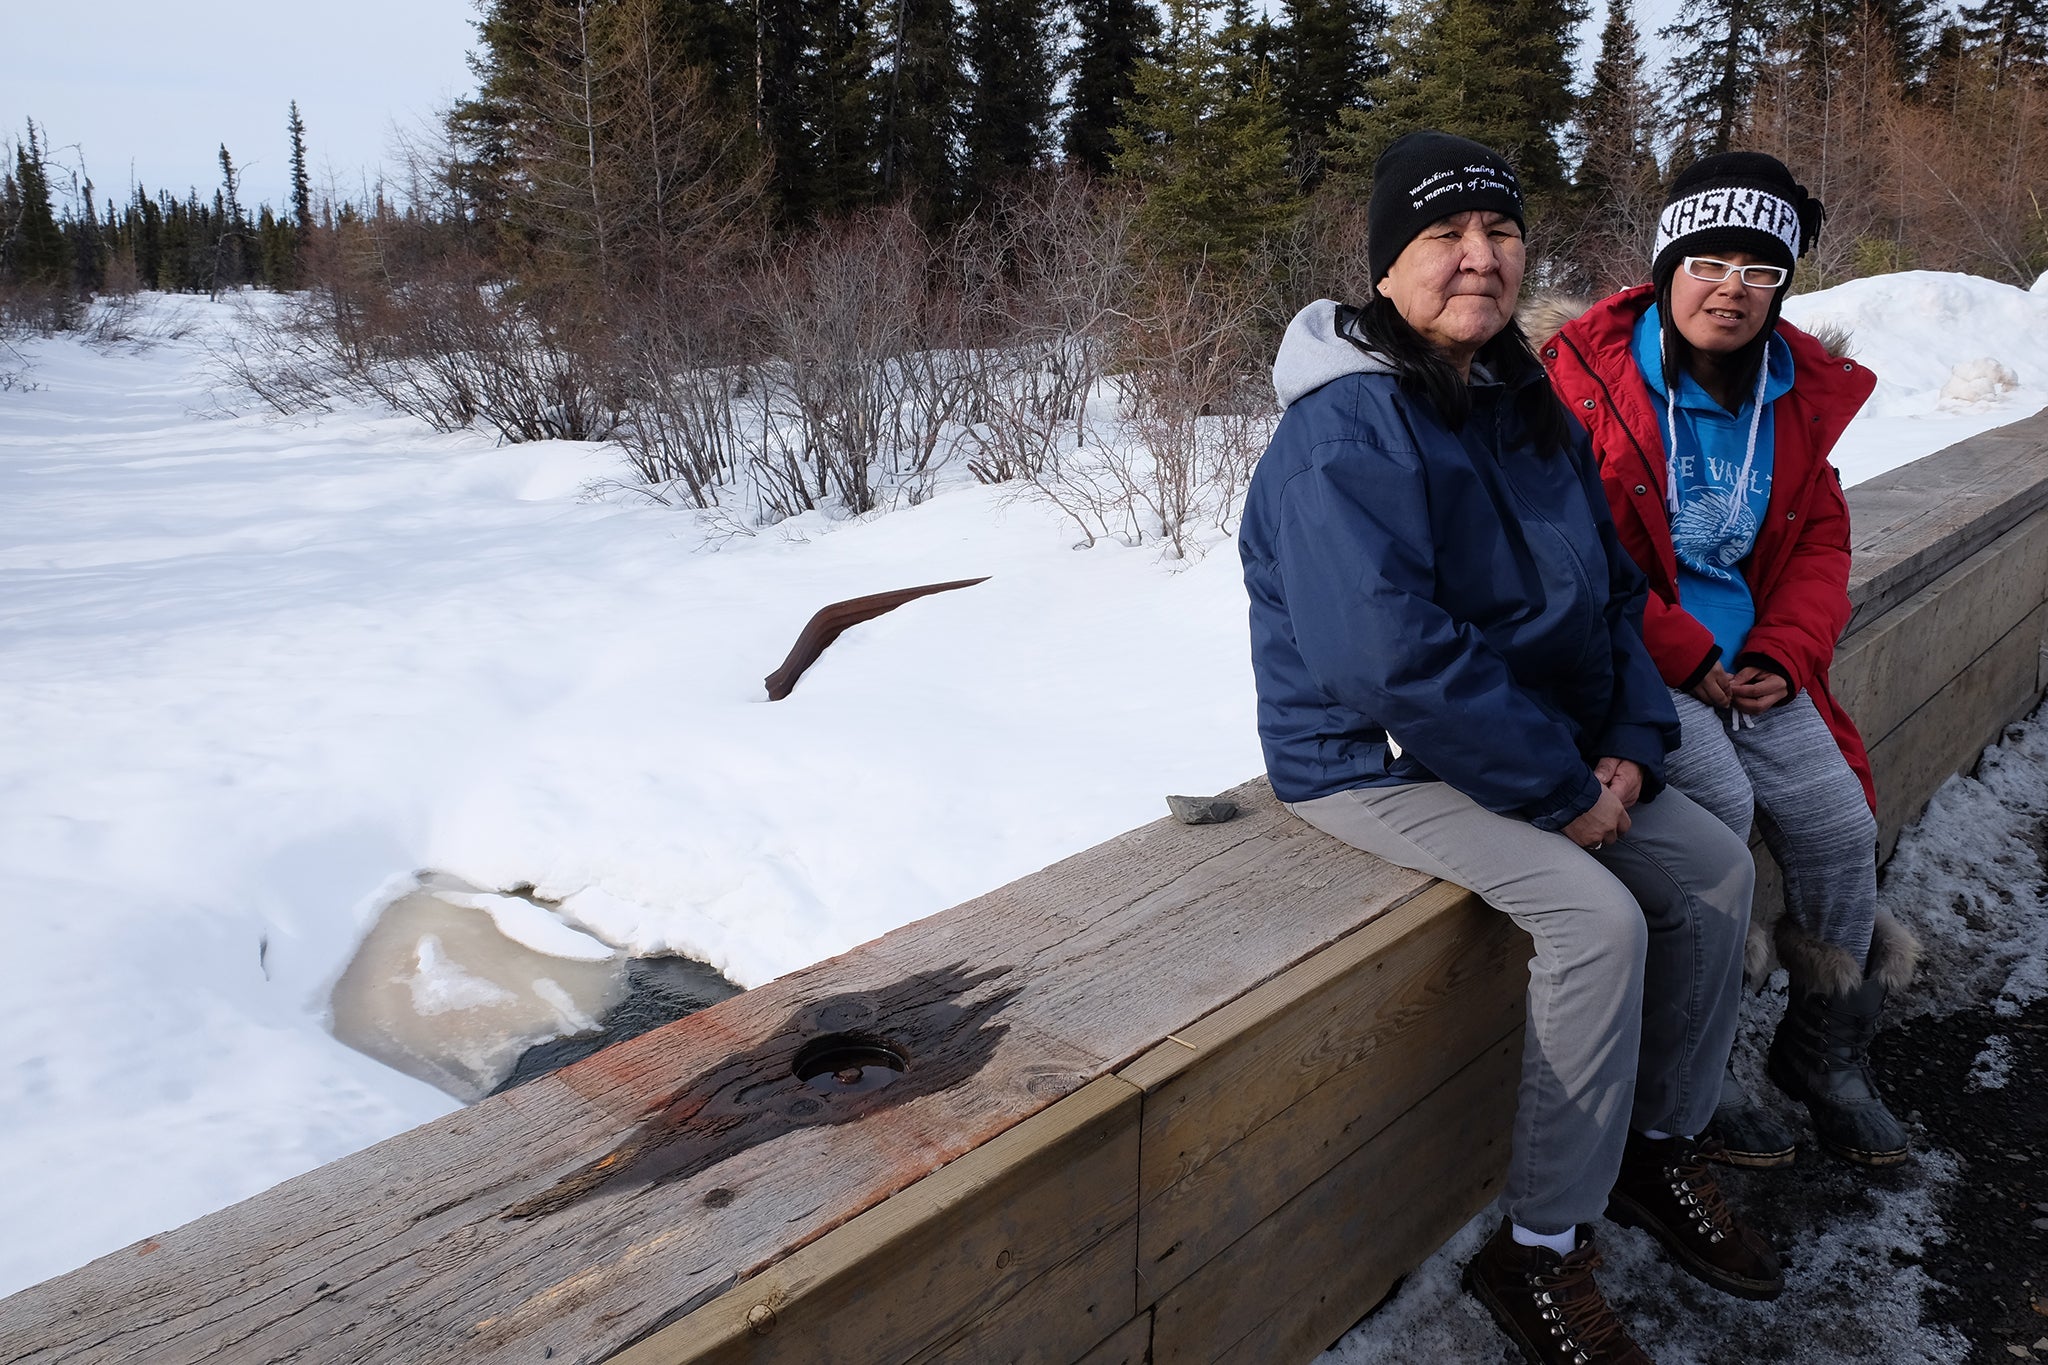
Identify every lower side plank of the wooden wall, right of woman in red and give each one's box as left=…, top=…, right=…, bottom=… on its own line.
left=1870, top=604, right=2048, bottom=857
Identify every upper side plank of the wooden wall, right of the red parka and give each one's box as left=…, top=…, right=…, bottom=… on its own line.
left=1833, top=510, right=2048, bottom=753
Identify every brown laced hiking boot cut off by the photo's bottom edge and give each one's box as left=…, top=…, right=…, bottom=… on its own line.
left=1464, top=1218, right=1651, bottom=1365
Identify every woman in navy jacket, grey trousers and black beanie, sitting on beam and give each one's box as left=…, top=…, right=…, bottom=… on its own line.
left=1239, top=133, right=1782, bottom=1363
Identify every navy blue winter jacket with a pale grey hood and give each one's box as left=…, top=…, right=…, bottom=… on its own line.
left=1237, top=299, right=1677, bottom=829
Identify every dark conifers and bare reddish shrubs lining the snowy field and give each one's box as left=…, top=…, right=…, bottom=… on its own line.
left=0, top=0, right=2048, bottom=551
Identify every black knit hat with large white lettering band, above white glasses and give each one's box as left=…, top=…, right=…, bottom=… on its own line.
left=1651, top=151, right=1827, bottom=284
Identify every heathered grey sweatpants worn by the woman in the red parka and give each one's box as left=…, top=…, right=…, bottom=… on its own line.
left=1669, top=692, right=1878, bottom=962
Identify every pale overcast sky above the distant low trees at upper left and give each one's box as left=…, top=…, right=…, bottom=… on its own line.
left=0, top=0, right=477, bottom=209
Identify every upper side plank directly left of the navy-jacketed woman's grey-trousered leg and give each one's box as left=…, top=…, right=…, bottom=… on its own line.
left=1118, top=884, right=1530, bottom=1302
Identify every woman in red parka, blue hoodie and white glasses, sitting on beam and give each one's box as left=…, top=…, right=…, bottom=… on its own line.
left=1542, top=151, right=1919, bottom=1166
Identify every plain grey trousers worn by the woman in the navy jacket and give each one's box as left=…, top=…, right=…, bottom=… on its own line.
left=1288, top=782, right=1755, bottom=1232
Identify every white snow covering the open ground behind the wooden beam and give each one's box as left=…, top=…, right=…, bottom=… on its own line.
left=0, top=274, right=2048, bottom=1309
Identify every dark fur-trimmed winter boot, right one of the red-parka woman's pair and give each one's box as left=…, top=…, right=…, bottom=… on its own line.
left=1767, top=915, right=1919, bottom=1166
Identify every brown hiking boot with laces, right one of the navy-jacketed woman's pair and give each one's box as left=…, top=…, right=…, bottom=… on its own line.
left=1608, top=1132, right=1786, bottom=1300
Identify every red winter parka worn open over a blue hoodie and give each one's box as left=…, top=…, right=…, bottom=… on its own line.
left=1542, top=284, right=1878, bottom=806
